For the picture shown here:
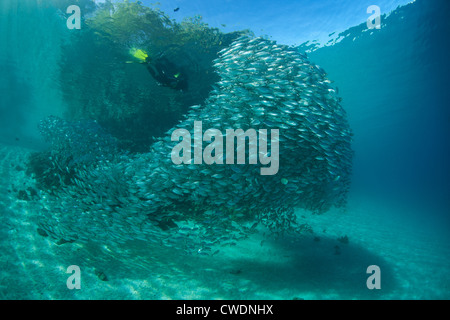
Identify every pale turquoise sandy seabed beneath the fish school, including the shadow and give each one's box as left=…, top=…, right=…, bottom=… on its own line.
left=0, top=146, right=450, bottom=300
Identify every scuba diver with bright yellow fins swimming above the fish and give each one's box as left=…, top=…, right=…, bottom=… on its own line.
left=130, top=48, right=188, bottom=91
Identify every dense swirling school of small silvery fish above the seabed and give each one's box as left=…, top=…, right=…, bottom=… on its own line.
left=39, top=36, right=353, bottom=255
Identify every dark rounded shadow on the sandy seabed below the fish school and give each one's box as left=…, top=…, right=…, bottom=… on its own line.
left=212, top=236, right=398, bottom=299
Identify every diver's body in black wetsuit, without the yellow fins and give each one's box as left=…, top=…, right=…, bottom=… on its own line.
left=147, top=57, right=188, bottom=91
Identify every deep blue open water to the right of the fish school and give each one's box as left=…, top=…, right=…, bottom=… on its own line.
left=311, top=1, right=450, bottom=220
